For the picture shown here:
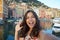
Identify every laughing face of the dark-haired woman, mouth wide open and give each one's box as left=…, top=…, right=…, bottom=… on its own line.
left=26, top=12, right=36, bottom=28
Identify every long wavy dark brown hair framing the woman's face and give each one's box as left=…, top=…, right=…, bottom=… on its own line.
left=18, top=10, right=42, bottom=37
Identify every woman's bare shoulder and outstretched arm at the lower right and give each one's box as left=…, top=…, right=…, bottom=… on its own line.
left=40, top=30, right=60, bottom=40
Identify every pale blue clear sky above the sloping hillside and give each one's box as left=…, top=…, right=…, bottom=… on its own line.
left=38, top=0, right=60, bottom=9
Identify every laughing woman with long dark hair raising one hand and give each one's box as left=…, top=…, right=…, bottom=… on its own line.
left=15, top=10, right=59, bottom=40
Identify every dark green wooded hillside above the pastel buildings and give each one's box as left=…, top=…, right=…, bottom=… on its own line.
left=15, top=0, right=49, bottom=8
